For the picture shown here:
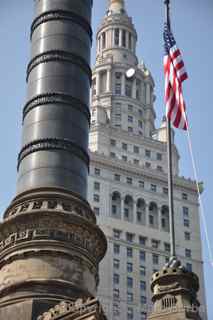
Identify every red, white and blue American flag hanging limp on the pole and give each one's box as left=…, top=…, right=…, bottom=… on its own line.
left=164, top=24, right=188, bottom=130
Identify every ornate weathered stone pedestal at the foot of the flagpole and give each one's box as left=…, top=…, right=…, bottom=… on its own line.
left=148, top=267, right=201, bottom=320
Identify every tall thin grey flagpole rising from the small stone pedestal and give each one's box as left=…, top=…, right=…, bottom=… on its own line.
left=164, top=0, right=176, bottom=260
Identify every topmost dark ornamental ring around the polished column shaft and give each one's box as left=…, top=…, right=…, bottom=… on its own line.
left=31, top=10, right=92, bottom=41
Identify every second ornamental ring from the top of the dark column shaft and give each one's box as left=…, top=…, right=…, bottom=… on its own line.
left=27, top=50, right=92, bottom=84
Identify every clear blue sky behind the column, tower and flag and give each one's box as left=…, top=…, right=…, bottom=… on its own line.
left=0, top=0, right=213, bottom=320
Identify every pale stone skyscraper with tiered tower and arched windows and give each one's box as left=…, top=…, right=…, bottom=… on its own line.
left=88, top=0, right=207, bottom=320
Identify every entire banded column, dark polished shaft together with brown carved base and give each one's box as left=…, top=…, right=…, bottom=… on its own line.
left=0, top=0, right=106, bottom=320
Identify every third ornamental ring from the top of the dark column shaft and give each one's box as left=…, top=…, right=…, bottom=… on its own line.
left=23, top=92, right=90, bottom=122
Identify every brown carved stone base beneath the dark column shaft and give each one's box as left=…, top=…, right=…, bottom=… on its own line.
left=0, top=189, right=106, bottom=320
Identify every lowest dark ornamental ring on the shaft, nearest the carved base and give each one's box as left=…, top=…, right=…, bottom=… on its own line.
left=18, top=138, right=89, bottom=169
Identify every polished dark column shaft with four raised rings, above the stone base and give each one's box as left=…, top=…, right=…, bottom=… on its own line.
left=17, top=0, right=92, bottom=197
